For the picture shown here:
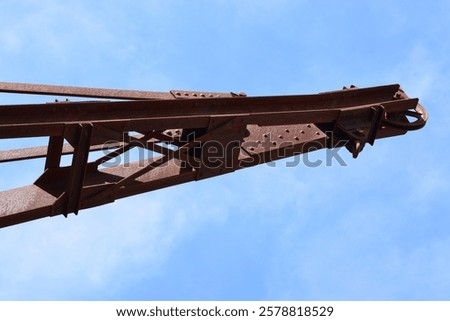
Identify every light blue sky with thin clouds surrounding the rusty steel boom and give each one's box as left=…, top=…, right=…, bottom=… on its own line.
left=0, top=0, right=450, bottom=300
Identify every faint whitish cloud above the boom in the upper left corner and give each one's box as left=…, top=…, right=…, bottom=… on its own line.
left=0, top=0, right=134, bottom=80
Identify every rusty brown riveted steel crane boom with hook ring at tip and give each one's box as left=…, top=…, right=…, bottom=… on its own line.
left=0, top=82, right=427, bottom=227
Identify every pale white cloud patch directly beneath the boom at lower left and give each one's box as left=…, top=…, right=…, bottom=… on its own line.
left=0, top=184, right=229, bottom=299
